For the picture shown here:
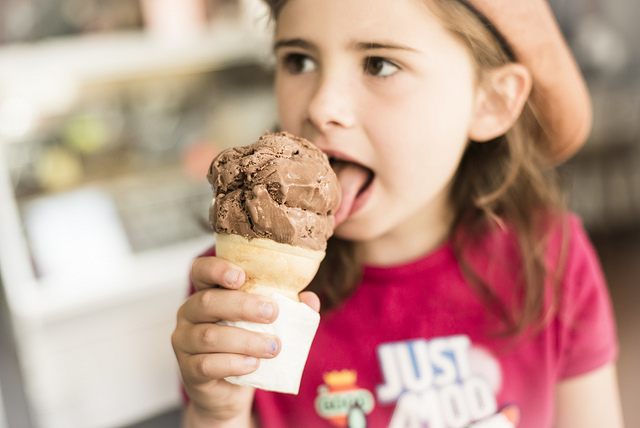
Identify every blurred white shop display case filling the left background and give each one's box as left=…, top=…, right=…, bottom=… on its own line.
left=0, top=0, right=276, bottom=428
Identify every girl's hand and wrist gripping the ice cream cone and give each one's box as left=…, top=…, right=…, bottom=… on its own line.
left=171, top=257, right=320, bottom=427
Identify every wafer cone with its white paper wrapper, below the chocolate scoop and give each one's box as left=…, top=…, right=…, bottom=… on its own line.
left=216, top=234, right=325, bottom=394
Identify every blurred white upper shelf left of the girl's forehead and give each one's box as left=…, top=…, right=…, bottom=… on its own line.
left=0, top=23, right=271, bottom=115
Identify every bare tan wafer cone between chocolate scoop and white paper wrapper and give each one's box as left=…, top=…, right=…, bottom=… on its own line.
left=216, top=233, right=325, bottom=302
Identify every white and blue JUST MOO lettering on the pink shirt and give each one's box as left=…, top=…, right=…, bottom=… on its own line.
left=376, top=335, right=520, bottom=428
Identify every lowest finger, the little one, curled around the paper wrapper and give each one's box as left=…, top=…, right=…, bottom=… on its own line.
left=180, top=354, right=260, bottom=384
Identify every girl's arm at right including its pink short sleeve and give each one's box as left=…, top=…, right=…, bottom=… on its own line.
left=555, top=218, right=624, bottom=428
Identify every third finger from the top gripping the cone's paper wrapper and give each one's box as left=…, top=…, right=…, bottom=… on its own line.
left=176, top=323, right=282, bottom=358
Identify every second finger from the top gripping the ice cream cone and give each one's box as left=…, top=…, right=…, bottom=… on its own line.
left=178, top=288, right=279, bottom=324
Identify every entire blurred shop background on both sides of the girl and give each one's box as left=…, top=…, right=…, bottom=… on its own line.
left=0, top=0, right=640, bottom=428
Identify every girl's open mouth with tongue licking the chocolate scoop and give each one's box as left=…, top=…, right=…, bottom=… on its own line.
left=329, top=157, right=375, bottom=226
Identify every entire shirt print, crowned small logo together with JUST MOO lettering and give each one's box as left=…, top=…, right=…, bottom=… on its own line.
left=315, top=335, right=520, bottom=428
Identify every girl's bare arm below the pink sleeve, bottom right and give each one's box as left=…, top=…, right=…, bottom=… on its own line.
left=555, top=363, right=624, bottom=428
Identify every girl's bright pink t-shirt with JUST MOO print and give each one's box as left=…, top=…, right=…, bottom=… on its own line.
left=248, top=217, right=617, bottom=428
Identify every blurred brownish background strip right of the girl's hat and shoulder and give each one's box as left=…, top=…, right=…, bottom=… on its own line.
left=551, top=0, right=640, bottom=427
